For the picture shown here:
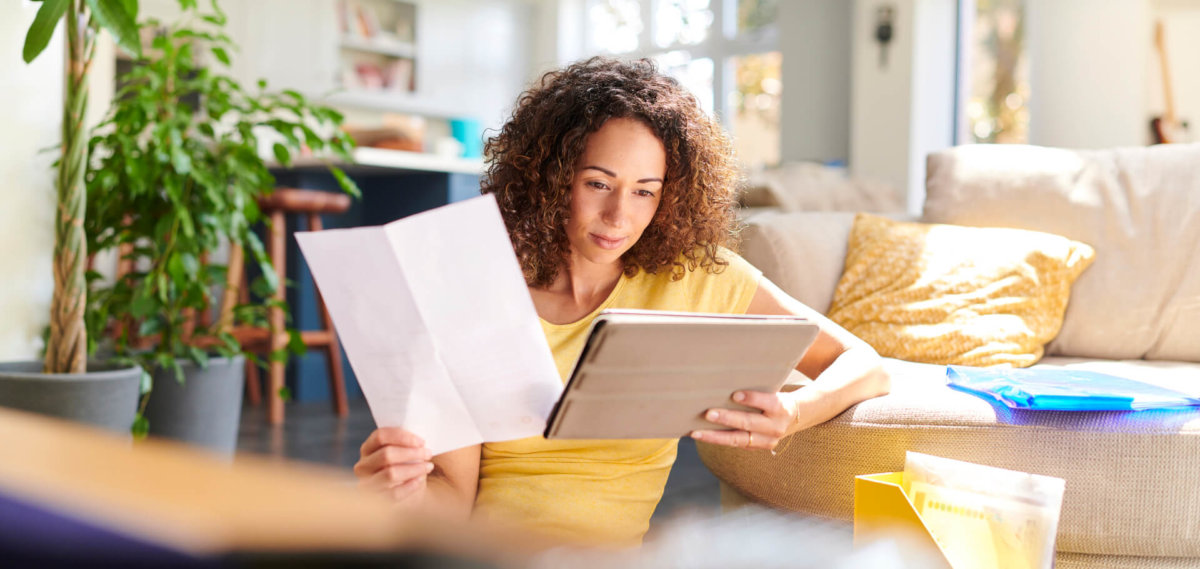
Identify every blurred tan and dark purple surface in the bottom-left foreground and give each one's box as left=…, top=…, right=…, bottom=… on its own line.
left=0, top=408, right=548, bottom=568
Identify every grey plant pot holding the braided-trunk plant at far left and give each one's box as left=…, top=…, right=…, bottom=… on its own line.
left=0, top=361, right=142, bottom=436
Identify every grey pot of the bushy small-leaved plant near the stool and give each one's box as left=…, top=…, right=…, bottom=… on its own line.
left=145, top=355, right=246, bottom=457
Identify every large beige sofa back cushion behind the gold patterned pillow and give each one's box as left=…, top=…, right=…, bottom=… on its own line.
left=923, top=144, right=1200, bottom=361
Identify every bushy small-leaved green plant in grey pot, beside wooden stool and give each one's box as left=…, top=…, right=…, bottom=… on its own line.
left=84, top=1, right=358, bottom=453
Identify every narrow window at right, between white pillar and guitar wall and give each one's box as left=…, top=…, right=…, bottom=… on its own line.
left=958, top=0, right=1030, bottom=144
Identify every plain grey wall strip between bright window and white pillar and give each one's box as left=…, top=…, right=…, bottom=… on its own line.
left=779, top=0, right=853, bottom=162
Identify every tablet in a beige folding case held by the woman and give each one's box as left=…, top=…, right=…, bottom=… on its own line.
left=545, top=310, right=818, bottom=438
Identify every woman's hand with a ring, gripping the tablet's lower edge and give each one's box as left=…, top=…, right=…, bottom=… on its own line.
left=691, top=391, right=797, bottom=451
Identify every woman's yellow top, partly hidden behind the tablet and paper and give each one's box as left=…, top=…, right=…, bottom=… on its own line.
left=475, top=248, right=761, bottom=546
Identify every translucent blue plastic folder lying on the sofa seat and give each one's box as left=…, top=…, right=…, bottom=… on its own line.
left=946, top=366, right=1200, bottom=411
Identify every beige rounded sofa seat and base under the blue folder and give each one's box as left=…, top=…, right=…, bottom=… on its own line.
left=697, top=358, right=1200, bottom=557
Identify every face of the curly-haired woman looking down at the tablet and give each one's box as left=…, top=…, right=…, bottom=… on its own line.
left=566, top=119, right=667, bottom=270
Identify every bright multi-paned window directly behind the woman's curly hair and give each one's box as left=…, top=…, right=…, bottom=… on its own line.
left=583, top=0, right=782, bottom=168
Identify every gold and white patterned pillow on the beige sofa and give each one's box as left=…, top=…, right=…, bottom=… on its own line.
left=829, top=214, right=1096, bottom=367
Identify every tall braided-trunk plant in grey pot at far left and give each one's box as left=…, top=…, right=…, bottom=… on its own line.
left=0, top=0, right=143, bottom=432
